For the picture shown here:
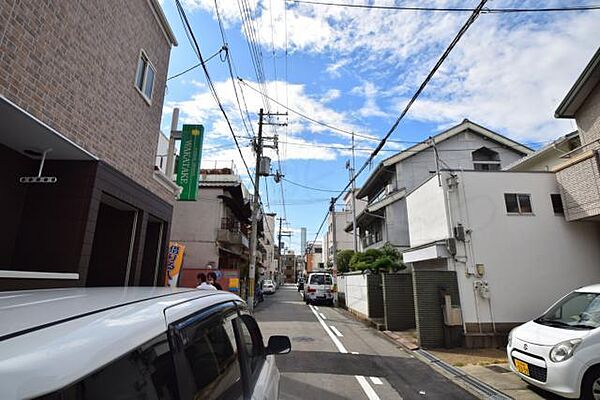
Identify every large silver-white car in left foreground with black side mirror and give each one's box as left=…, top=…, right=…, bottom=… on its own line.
left=0, top=287, right=291, bottom=400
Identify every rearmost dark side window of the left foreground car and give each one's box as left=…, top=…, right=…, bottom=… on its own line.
left=38, top=334, right=179, bottom=400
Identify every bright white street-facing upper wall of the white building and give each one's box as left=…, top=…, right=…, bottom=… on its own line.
left=406, top=177, right=448, bottom=247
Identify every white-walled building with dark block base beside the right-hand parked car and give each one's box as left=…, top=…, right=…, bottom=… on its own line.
left=403, top=171, right=600, bottom=347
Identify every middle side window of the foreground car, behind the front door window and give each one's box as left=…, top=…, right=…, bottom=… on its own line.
left=178, top=306, right=243, bottom=399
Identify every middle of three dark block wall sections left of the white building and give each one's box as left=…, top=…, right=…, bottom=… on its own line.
left=382, top=273, right=416, bottom=331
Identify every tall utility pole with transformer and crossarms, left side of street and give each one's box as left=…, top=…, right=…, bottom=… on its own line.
left=246, top=108, right=287, bottom=312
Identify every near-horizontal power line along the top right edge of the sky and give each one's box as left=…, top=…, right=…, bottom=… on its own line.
left=286, top=0, right=600, bottom=14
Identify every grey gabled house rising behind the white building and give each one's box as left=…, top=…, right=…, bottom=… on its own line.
left=356, top=120, right=533, bottom=251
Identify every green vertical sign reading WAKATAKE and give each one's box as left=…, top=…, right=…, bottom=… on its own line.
left=177, top=125, right=204, bottom=201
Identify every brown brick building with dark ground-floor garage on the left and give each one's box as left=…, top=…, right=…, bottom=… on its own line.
left=0, top=0, right=177, bottom=290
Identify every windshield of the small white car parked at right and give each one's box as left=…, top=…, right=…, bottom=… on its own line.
left=535, top=292, right=600, bottom=329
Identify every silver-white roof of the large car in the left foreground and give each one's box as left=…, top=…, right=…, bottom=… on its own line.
left=0, top=287, right=240, bottom=399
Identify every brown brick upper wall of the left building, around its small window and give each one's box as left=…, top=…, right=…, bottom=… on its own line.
left=0, top=0, right=173, bottom=203
